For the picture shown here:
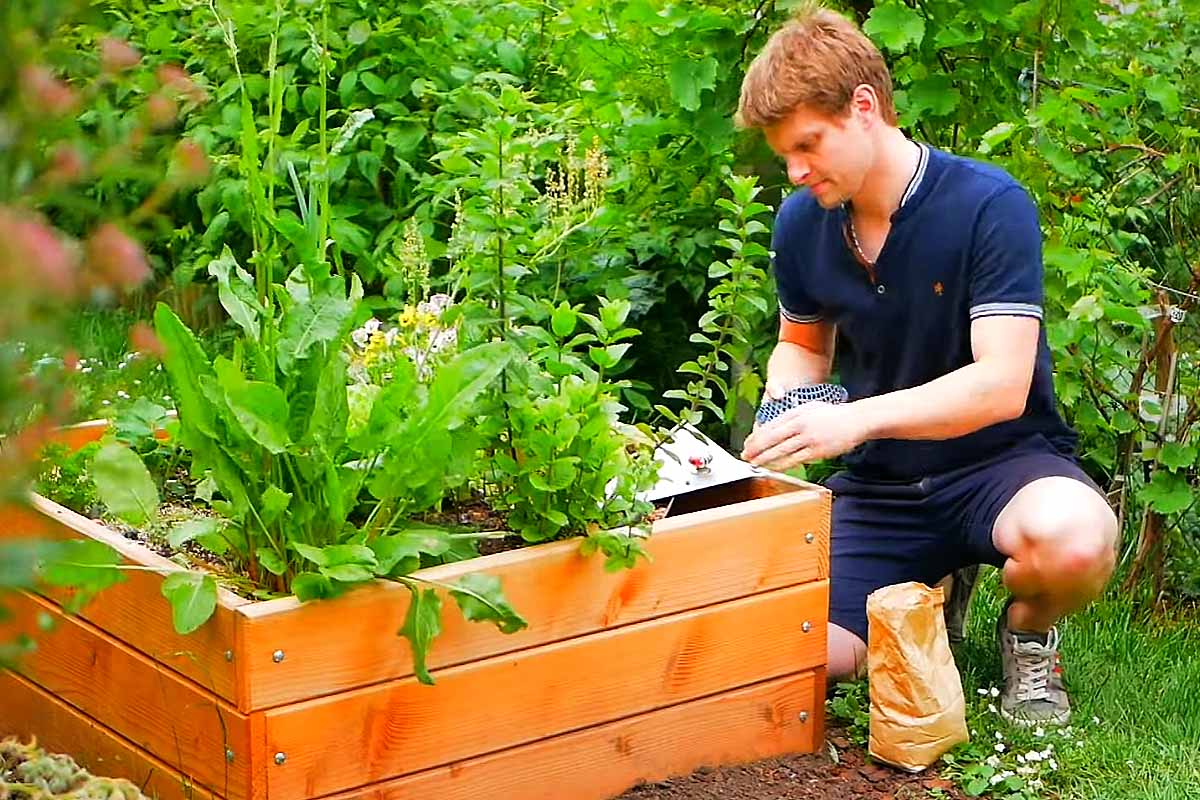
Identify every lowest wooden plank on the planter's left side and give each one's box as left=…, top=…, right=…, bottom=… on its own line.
left=0, top=670, right=220, bottom=800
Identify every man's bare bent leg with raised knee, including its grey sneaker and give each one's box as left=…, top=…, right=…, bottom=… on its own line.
left=992, top=476, right=1117, bottom=726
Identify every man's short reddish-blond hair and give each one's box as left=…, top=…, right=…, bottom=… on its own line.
left=734, top=2, right=896, bottom=128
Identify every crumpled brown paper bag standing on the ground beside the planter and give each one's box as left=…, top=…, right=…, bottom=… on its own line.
left=866, top=582, right=968, bottom=772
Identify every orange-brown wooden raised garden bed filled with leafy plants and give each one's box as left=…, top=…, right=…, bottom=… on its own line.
left=0, top=419, right=830, bottom=800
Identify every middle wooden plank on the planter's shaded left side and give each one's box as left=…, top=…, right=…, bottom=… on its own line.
left=0, top=593, right=250, bottom=800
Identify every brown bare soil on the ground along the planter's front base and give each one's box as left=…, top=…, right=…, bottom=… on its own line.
left=614, top=728, right=966, bottom=800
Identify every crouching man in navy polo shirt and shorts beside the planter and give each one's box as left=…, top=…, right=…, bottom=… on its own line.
left=738, top=8, right=1117, bottom=724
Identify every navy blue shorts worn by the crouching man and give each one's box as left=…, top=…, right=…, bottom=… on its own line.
left=826, top=437, right=1103, bottom=642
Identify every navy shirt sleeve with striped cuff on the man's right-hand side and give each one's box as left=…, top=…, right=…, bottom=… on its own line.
left=970, top=186, right=1044, bottom=320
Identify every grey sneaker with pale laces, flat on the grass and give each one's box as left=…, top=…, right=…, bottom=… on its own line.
left=997, top=601, right=1070, bottom=727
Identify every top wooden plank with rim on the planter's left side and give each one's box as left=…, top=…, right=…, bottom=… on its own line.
left=0, top=495, right=243, bottom=703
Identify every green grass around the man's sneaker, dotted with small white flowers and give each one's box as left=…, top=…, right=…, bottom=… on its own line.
left=830, top=567, right=1200, bottom=800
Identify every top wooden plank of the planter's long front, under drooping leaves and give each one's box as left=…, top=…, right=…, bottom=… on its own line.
left=239, top=487, right=829, bottom=711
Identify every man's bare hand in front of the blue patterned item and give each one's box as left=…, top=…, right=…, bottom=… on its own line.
left=742, top=403, right=868, bottom=471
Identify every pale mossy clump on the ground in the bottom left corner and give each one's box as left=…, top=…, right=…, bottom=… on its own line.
left=0, top=739, right=149, bottom=800
